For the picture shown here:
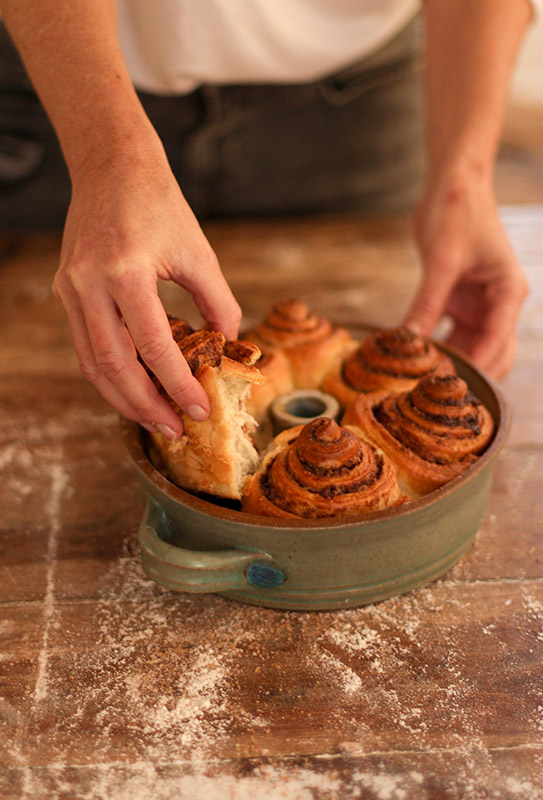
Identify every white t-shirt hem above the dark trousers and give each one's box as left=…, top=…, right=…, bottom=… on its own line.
left=117, top=0, right=420, bottom=94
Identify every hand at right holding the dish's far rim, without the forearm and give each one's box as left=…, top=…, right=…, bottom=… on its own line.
left=404, top=168, right=528, bottom=378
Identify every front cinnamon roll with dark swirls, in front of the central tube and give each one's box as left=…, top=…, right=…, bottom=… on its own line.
left=242, top=417, right=407, bottom=518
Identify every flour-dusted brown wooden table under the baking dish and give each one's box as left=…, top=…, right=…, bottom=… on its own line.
left=0, top=206, right=543, bottom=800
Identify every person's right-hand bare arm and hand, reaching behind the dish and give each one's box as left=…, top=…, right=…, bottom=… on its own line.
left=405, top=0, right=531, bottom=377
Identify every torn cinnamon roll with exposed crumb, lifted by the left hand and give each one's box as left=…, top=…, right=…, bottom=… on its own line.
left=150, top=320, right=265, bottom=500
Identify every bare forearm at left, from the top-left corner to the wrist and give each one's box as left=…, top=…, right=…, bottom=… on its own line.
left=0, top=0, right=165, bottom=179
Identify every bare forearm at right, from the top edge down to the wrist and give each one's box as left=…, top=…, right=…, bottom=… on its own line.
left=424, top=0, right=532, bottom=178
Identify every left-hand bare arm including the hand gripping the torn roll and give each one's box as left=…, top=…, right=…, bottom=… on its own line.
left=1, top=0, right=241, bottom=438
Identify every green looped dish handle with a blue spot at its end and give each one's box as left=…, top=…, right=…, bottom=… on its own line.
left=138, top=500, right=287, bottom=593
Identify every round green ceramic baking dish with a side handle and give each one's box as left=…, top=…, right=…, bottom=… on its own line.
left=121, top=346, right=510, bottom=610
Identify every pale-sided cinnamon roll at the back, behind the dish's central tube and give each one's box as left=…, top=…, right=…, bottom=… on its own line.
left=246, top=300, right=352, bottom=389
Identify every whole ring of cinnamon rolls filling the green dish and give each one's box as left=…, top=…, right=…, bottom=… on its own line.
left=151, top=300, right=494, bottom=518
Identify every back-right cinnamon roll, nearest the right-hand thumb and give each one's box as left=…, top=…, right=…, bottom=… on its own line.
left=321, top=327, right=455, bottom=408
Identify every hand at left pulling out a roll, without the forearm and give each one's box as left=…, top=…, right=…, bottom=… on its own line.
left=54, top=154, right=241, bottom=439
